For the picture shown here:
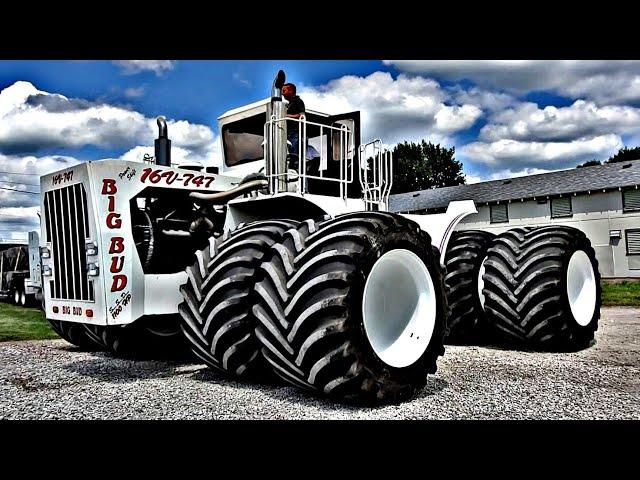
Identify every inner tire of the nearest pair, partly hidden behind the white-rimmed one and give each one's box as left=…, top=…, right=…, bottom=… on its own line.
left=178, top=220, right=298, bottom=378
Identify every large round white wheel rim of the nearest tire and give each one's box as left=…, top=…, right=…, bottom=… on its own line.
left=362, top=249, right=437, bottom=368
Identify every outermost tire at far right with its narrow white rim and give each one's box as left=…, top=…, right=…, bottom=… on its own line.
left=483, top=226, right=602, bottom=351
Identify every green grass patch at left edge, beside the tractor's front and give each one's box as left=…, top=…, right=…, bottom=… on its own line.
left=0, top=302, right=59, bottom=342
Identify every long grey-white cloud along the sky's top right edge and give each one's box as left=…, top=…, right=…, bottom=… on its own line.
left=385, top=60, right=640, bottom=103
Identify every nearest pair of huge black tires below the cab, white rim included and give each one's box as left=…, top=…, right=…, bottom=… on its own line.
left=179, top=212, right=446, bottom=403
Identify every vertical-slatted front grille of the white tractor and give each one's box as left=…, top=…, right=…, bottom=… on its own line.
left=44, top=183, right=94, bottom=302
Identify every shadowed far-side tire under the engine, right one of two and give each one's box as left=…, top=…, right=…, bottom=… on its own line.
left=96, top=315, right=188, bottom=359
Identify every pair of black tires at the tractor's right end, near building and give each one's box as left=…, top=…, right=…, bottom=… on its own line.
left=445, top=226, right=601, bottom=351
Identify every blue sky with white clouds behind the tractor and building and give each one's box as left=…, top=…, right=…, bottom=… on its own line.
left=0, top=60, right=640, bottom=241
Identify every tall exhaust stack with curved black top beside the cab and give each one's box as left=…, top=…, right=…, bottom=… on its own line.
left=265, top=70, right=287, bottom=193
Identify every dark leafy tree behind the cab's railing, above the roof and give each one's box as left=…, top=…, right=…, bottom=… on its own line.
left=392, top=140, right=465, bottom=193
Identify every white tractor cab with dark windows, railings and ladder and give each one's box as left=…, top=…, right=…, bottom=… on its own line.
left=218, top=98, right=392, bottom=209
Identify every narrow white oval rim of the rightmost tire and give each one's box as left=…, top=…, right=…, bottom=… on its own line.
left=567, top=250, right=597, bottom=327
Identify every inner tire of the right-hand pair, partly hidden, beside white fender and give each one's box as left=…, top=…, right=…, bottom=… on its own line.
left=444, top=230, right=495, bottom=344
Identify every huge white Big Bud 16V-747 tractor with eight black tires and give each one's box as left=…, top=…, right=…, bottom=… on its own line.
left=41, top=71, right=599, bottom=402
